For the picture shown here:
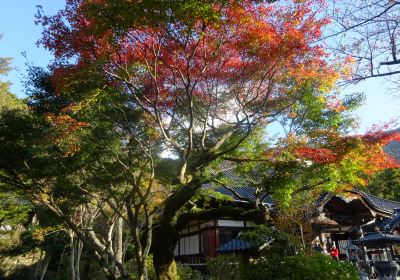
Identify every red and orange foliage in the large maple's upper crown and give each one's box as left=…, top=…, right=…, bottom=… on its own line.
left=41, top=0, right=337, bottom=110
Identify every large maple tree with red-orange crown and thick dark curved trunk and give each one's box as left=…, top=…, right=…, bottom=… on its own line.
left=30, top=0, right=400, bottom=279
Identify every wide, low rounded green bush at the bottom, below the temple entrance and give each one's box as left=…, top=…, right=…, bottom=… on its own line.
left=244, top=254, right=360, bottom=280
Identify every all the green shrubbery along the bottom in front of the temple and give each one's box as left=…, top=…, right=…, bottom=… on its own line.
left=203, top=226, right=360, bottom=280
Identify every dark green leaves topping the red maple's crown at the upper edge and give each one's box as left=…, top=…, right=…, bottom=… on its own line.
left=83, top=0, right=228, bottom=36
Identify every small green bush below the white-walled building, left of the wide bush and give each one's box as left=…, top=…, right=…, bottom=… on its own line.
left=206, top=255, right=241, bottom=280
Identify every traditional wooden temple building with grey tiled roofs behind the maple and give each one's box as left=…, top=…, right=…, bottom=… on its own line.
left=174, top=186, right=400, bottom=275
